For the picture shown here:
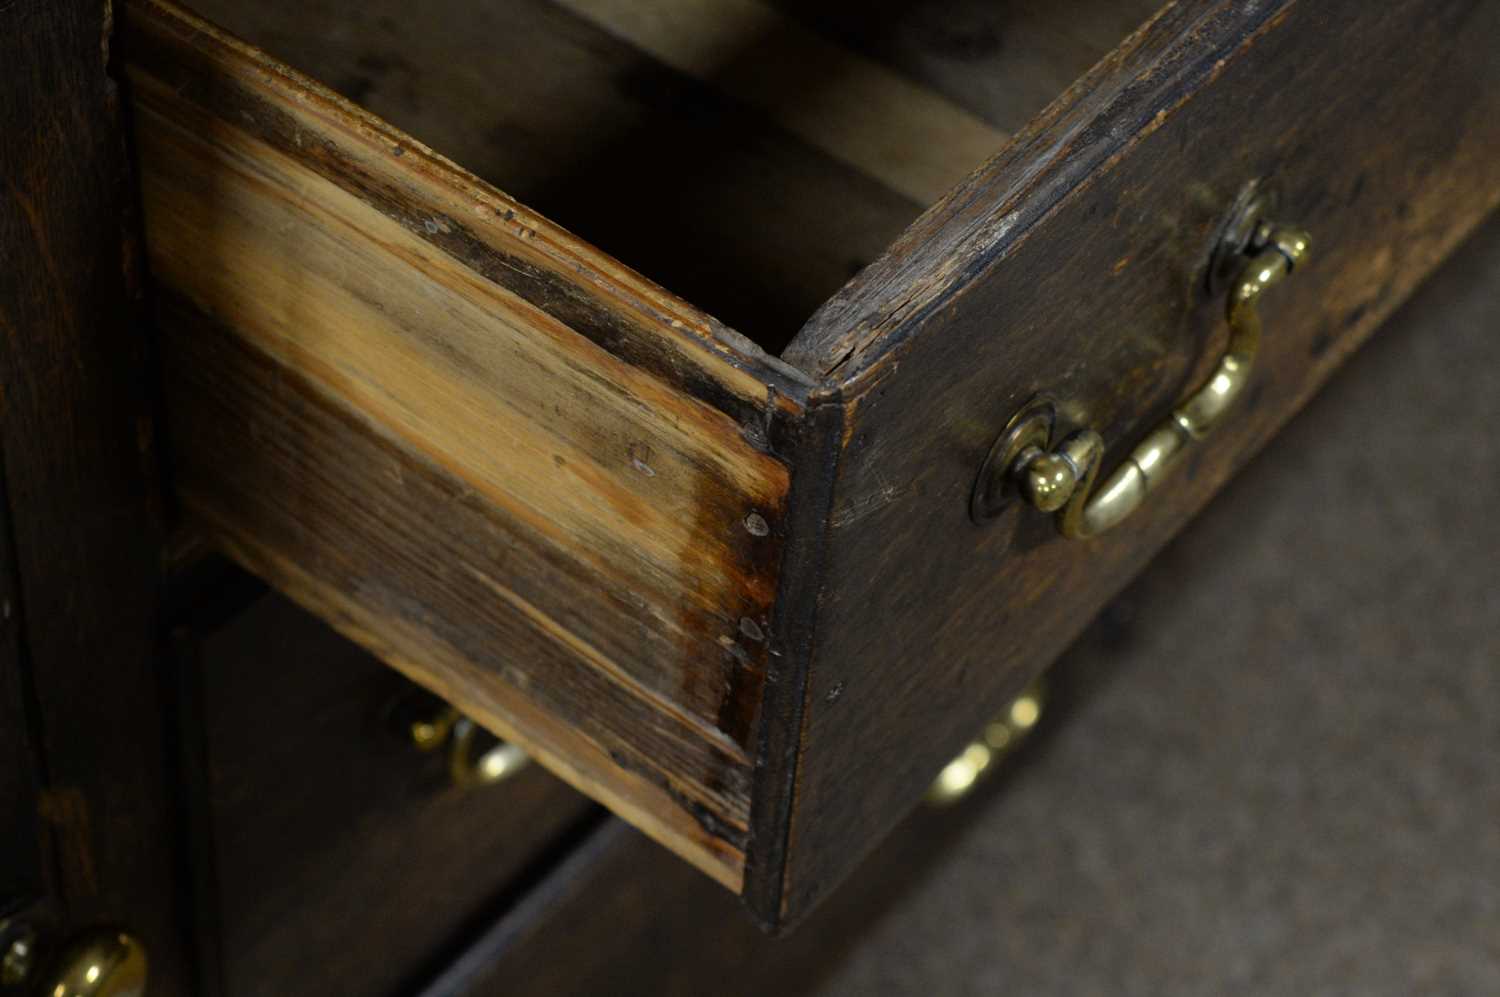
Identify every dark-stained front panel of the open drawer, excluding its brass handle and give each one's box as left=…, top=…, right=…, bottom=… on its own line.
left=762, top=0, right=1500, bottom=919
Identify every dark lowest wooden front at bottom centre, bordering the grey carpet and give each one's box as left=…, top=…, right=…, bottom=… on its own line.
left=417, top=783, right=1001, bottom=997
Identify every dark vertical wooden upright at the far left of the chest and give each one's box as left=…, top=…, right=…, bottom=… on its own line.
left=0, top=0, right=188, bottom=977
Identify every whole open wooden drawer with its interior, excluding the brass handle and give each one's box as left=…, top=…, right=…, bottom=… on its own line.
left=126, top=0, right=1500, bottom=925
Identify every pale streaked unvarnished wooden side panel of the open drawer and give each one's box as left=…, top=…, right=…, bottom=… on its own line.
left=128, top=3, right=804, bottom=886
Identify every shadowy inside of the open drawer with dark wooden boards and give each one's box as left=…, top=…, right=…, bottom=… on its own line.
left=175, top=0, right=1158, bottom=354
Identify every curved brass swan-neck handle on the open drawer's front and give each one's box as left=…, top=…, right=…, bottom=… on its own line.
left=969, top=200, right=1308, bottom=540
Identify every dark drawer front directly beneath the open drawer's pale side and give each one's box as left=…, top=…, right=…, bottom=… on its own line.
left=186, top=584, right=593, bottom=997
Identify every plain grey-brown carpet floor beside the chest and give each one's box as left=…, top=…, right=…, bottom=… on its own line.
left=813, top=223, right=1500, bottom=997
